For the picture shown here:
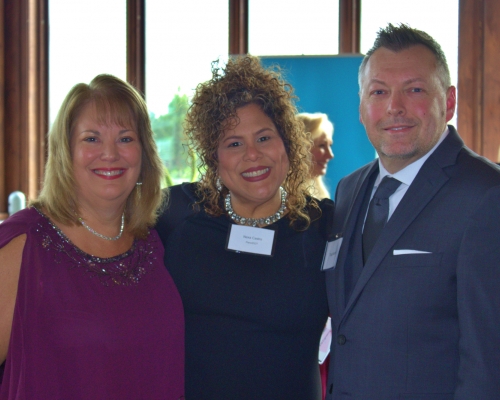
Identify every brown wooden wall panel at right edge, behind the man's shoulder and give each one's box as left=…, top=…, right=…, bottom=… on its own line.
left=458, top=0, right=500, bottom=162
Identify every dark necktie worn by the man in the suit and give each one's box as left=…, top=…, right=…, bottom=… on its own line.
left=363, top=176, right=401, bottom=263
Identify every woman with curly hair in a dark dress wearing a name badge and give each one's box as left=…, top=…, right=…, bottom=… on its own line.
left=157, top=56, right=332, bottom=399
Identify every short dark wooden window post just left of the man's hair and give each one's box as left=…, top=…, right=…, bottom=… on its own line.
left=339, top=0, right=361, bottom=54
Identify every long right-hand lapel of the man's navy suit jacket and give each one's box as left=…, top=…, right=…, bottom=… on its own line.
left=337, top=127, right=463, bottom=318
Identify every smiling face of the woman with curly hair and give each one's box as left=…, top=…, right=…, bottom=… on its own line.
left=217, top=104, right=289, bottom=217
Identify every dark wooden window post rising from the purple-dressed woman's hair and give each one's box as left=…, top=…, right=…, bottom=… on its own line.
left=127, top=0, right=146, bottom=95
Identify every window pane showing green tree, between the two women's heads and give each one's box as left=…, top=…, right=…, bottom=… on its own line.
left=146, top=0, right=229, bottom=184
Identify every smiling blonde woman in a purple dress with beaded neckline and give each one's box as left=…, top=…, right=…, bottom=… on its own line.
left=0, top=75, right=184, bottom=400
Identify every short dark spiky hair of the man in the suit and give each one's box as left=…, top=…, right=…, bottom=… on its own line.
left=358, top=24, right=451, bottom=90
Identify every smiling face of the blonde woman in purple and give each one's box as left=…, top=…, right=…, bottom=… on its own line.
left=71, top=103, right=142, bottom=211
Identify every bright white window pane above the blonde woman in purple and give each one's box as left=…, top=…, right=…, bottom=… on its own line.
left=49, top=0, right=127, bottom=123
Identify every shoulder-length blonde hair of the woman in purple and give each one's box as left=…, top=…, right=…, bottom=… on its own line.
left=31, top=74, right=164, bottom=237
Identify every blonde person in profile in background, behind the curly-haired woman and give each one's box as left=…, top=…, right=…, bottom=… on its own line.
left=297, top=113, right=333, bottom=199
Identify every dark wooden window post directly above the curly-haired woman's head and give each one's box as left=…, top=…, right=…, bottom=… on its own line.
left=229, top=0, right=248, bottom=54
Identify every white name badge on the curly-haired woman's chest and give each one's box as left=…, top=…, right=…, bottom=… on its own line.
left=226, top=224, right=275, bottom=256
